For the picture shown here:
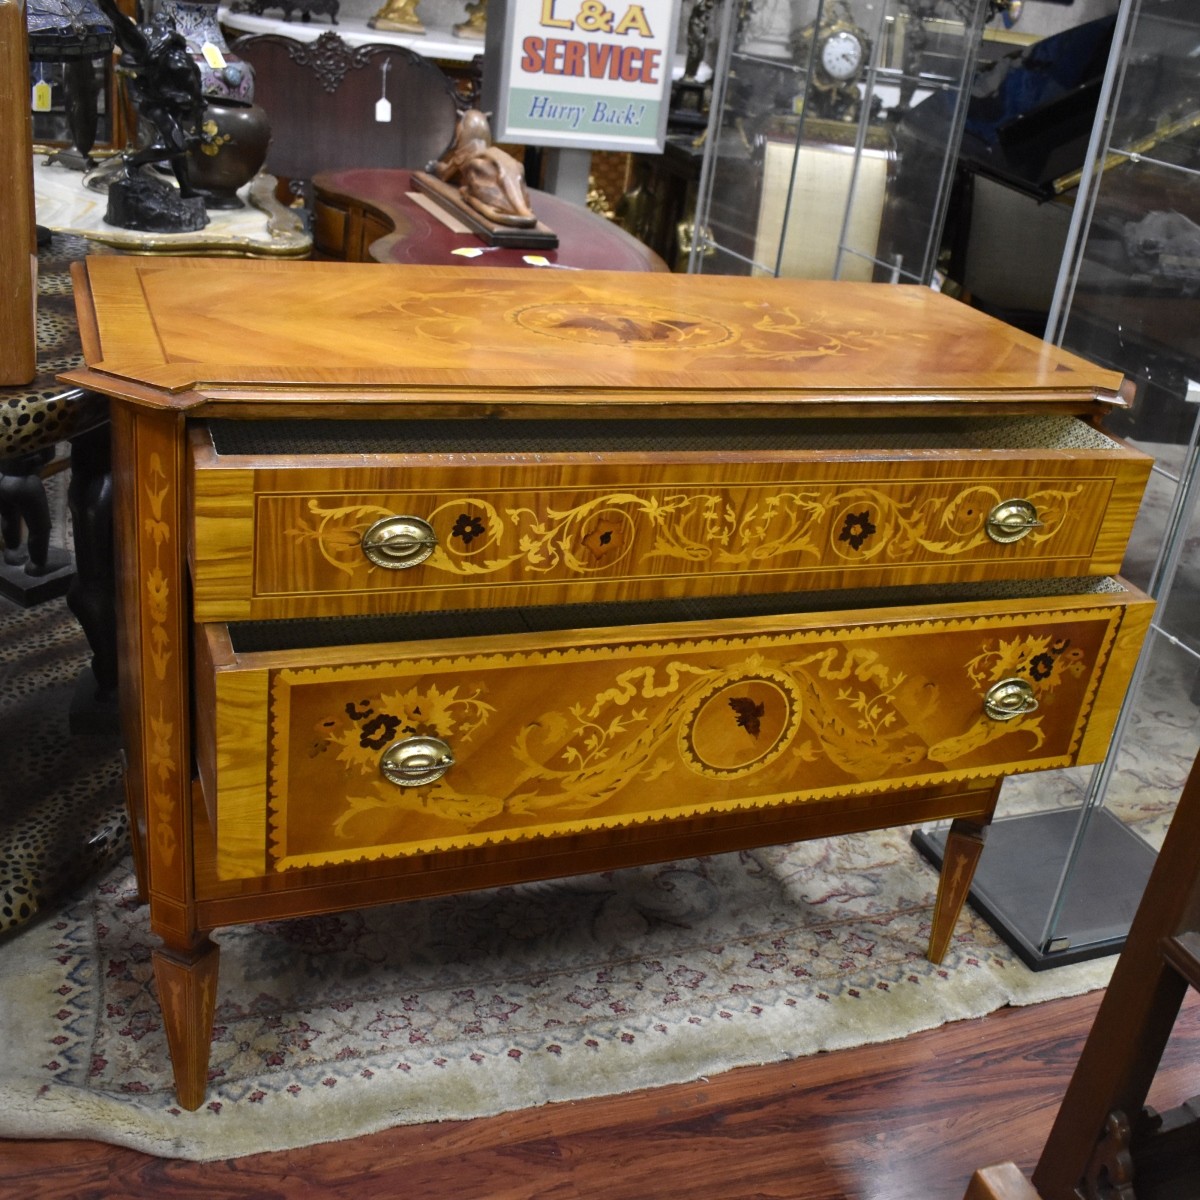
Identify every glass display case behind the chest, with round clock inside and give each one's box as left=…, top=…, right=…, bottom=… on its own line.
left=689, top=0, right=1000, bottom=283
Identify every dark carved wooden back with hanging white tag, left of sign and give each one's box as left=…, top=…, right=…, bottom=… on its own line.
left=230, top=32, right=462, bottom=184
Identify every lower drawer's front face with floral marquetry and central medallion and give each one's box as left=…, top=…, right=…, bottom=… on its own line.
left=199, top=590, right=1140, bottom=874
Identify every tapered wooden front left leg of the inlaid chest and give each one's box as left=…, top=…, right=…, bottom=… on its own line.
left=154, top=937, right=220, bottom=1109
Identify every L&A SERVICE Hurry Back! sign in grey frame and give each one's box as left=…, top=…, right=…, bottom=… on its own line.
left=484, top=0, right=679, bottom=151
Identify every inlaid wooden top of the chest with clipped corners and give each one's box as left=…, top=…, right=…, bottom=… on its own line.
left=65, top=257, right=1121, bottom=417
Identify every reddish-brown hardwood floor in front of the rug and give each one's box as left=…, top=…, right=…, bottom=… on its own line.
left=7, top=992, right=1200, bottom=1200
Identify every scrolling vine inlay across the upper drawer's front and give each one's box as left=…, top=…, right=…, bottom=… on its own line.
left=278, top=480, right=1084, bottom=592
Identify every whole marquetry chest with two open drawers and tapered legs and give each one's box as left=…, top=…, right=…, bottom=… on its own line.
left=70, top=257, right=1150, bottom=1106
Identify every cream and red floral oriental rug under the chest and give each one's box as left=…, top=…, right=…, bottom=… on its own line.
left=0, top=590, right=1190, bottom=1159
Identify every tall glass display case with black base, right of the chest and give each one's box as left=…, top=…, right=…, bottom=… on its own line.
left=917, top=0, right=1200, bottom=970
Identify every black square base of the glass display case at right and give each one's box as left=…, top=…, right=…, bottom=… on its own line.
left=912, top=809, right=1158, bottom=971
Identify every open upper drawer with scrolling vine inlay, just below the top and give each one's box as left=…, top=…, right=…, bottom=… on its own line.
left=192, top=415, right=1151, bottom=620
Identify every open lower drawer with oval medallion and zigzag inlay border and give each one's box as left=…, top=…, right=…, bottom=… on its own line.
left=197, top=580, right=1152, bottom=880
